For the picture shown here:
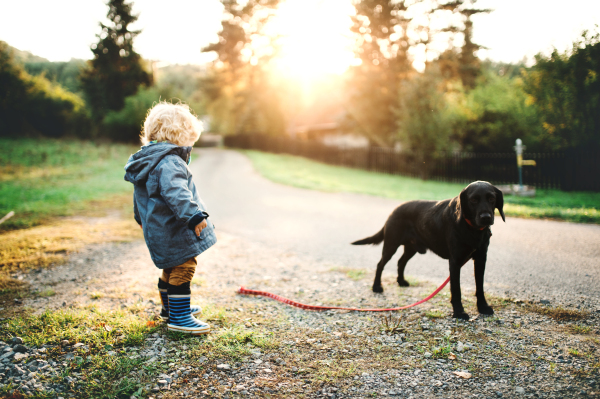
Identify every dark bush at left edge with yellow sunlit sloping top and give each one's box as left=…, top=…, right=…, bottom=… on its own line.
left=0, top=42, right=88, bottom=137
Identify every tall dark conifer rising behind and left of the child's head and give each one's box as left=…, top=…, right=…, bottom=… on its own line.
left=81, top=0, right=152, bottom=129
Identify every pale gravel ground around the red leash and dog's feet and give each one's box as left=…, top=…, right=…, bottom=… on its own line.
left=0, top=232, right=600, bottom=399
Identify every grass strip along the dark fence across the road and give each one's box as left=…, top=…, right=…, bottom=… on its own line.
left=243, top=151, right=600, bottom=223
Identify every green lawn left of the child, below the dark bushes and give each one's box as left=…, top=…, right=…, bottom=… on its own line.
left=0, top=138, right=138, bottom=230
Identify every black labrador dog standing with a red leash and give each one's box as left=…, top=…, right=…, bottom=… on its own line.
left=352, top=181, right=506, bottom=320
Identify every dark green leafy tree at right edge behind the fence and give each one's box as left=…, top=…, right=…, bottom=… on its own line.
left=523, top=32, right=600, bottom=150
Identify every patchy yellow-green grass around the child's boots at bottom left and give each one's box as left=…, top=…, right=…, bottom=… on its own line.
left=0, top=304, right=280, bottom=399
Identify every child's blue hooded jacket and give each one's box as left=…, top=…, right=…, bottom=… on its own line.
left=125, top=143, right=217, bottom=269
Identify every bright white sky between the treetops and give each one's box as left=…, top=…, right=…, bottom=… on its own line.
left=0, top=0, right=600, bottom=71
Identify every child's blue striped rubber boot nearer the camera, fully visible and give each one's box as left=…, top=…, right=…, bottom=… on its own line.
left=167, top=283, right=210, bottom=335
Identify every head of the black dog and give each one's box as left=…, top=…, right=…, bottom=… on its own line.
left=459, top=181, right=506, bottom=228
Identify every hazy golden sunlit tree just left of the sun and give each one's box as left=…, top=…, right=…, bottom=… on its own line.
left=202, top=0, right=285, bottom=134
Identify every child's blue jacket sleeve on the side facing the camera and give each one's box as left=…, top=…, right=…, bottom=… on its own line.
left=158, top=160, right=208, bottom=230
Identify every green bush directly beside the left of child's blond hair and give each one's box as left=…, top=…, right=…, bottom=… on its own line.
left=103, top=87, right=161, bottom=142
